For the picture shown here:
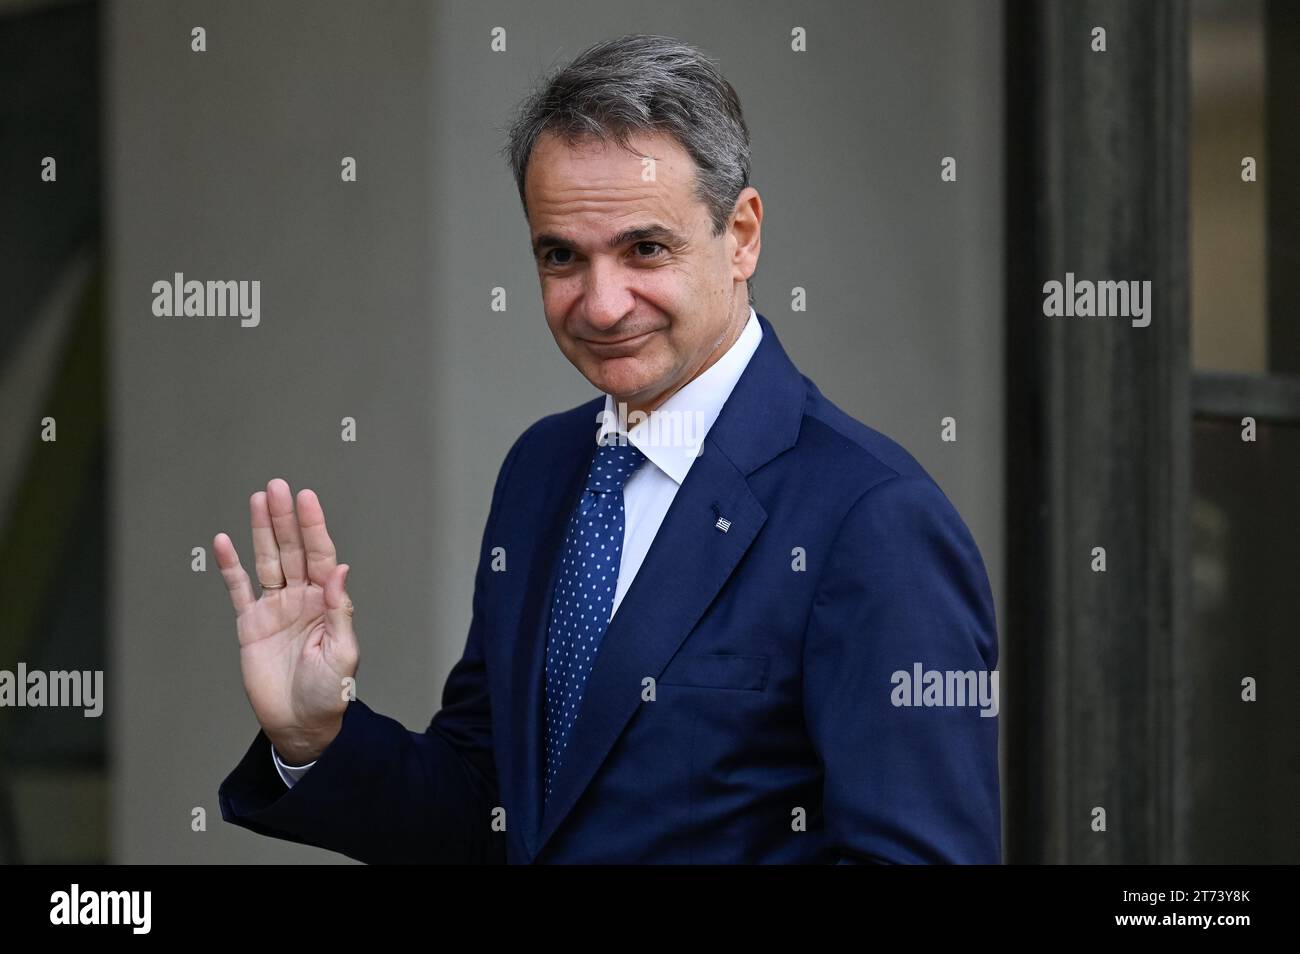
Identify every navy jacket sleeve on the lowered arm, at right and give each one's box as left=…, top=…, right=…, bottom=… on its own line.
left=803, top=476, right=1001, bottom=864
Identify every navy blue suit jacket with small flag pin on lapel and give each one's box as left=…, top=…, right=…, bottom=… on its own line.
left=220, top=316, right=1001, bottom=863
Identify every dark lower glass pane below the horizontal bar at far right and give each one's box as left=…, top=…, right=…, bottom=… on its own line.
left=1183, top=421, right=1300, bottom=863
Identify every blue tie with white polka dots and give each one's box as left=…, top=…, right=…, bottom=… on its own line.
left=545, top=438, right=645, bottom=798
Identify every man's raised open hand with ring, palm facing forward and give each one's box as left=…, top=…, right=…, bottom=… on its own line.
left=212, top=478, right=360, bottom=764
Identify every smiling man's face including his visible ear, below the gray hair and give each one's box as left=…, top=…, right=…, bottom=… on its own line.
left=524, top=134, right=762, bottom=409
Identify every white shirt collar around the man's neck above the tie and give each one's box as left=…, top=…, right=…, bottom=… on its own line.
left=595, top=305, right=763, bottom=485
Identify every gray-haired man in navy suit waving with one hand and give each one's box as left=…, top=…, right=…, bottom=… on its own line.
left=215, top=36, right=1000, bottom=863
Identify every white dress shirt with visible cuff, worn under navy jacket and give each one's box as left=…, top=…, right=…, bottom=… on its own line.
left=270, top=305, right=763, bottom=786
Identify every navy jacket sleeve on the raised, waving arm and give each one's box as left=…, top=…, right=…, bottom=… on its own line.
left=218, top=432, right=528, bottom=864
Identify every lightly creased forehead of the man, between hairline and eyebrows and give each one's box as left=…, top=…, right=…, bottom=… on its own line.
left=524, top=133, right=702, bottom=233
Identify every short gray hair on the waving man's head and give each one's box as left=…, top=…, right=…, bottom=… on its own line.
left=502, top=34, right=754, bottom=303
